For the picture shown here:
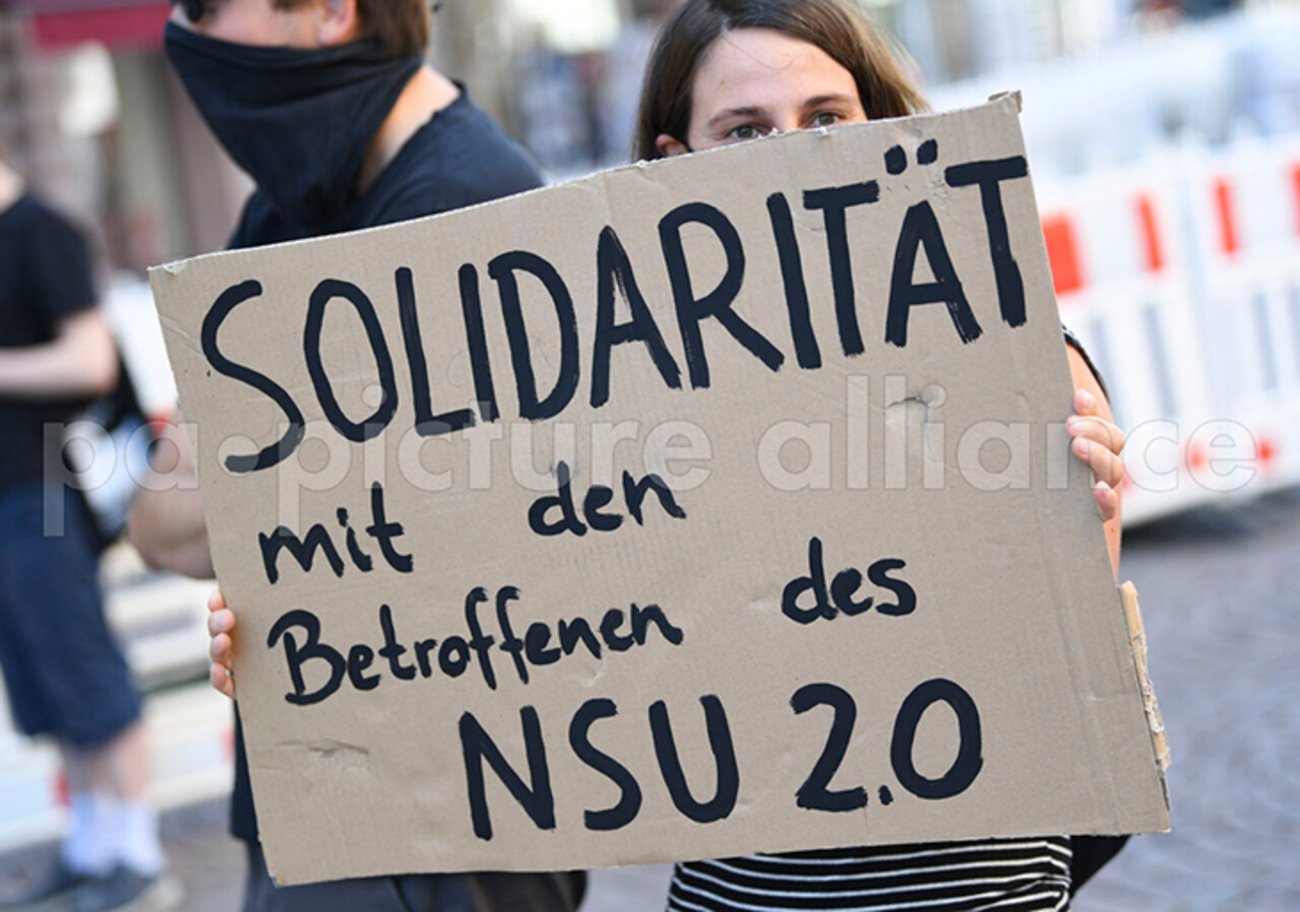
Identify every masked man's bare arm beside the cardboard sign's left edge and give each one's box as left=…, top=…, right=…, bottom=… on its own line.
left=127, top=416, right=215, bottom=579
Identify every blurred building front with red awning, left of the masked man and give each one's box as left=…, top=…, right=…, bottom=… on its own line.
left=0, top=0, right=248, bottom=274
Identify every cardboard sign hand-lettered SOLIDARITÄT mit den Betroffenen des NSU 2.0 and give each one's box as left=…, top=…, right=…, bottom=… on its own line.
left=152, top=99, right=1167, bottom=883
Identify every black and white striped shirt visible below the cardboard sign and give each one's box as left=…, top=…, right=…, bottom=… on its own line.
left=668, top=837, right=1071, bottom=912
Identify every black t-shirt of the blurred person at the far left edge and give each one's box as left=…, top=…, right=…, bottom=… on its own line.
left=0, top=196, right=96, bottom=491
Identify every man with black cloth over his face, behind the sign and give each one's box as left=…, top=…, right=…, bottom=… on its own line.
left=131, top=0, right=585, bottom=912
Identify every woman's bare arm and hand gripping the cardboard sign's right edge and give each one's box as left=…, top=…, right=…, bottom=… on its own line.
left=1066, top=346, right=1125, bottom=576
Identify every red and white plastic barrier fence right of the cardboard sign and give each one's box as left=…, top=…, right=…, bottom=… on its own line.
left=1037, top=136, right=1300, bottom=522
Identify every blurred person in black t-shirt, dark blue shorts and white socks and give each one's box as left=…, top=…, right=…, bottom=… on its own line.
left=0, top=157, right=181, bottom=912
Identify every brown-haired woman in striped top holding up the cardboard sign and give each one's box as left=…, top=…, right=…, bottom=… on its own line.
left=636, top=0, right=1123, bottom=912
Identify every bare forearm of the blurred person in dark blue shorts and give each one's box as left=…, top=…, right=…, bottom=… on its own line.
left=0, top=309, right=117, bottom=401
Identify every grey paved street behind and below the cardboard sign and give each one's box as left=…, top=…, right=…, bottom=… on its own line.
left=0, top=491, right=1300, bottom=912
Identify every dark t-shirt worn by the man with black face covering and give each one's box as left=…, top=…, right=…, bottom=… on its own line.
left=230, top=88, right=542, bottom=839
